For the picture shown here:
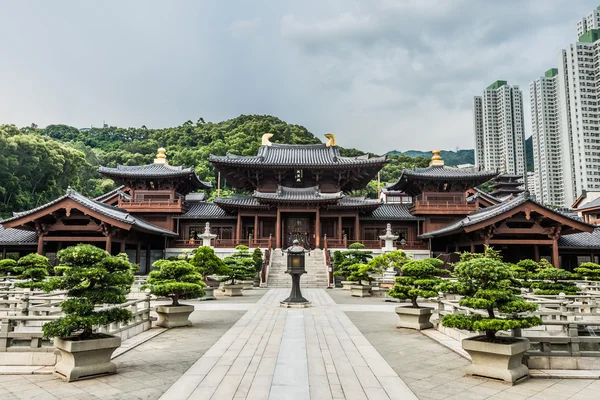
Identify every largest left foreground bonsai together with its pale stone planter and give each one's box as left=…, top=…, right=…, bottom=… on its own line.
left=42, top=244, right=133, bottom=381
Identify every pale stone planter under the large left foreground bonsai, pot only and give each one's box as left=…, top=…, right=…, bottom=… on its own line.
left=54, top=335, right=121, bottom=382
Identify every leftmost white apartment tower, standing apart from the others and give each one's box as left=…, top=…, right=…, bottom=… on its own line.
left=474, top=81, right=526, bottom=177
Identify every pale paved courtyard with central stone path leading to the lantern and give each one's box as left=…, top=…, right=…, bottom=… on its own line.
left=0, top=289, right=600, bottom=400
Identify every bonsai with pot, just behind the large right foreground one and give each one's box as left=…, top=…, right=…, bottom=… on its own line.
left=388, top=258, right=447, bottom=330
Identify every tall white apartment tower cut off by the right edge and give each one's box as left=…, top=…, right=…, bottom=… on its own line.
left=558, top=28, right=600, bottom=205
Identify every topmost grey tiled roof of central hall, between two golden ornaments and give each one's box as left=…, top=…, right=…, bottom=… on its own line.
left=209, top=143, right=387, bottom=167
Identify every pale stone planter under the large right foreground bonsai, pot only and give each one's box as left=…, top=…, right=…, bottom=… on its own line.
left=462, top=335, right=529, bottom=384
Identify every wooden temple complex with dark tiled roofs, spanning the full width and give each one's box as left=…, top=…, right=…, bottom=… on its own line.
left=0, top=134, right=600, bottom=272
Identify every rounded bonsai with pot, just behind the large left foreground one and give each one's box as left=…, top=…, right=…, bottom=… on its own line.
left=143, top=260, right=204, bottom=328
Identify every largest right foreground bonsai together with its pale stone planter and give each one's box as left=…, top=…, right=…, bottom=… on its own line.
left=441, top=248, right=542, bottom=383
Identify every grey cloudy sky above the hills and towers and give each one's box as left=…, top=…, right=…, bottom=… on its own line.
left=0, top=0, right=599, bottom=152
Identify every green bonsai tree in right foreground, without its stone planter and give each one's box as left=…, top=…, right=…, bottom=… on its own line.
left=441, top=248, right=542, bottom=342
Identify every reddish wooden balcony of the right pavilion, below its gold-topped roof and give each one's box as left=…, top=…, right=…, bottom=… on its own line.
left=410, top=192, right=477, bottom=215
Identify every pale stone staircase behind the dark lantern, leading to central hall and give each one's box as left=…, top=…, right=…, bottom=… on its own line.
left=267, top=249, right=327, bottom=288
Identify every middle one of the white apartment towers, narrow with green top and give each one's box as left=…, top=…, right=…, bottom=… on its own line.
left=529, top=68, right=566, bottom=206
